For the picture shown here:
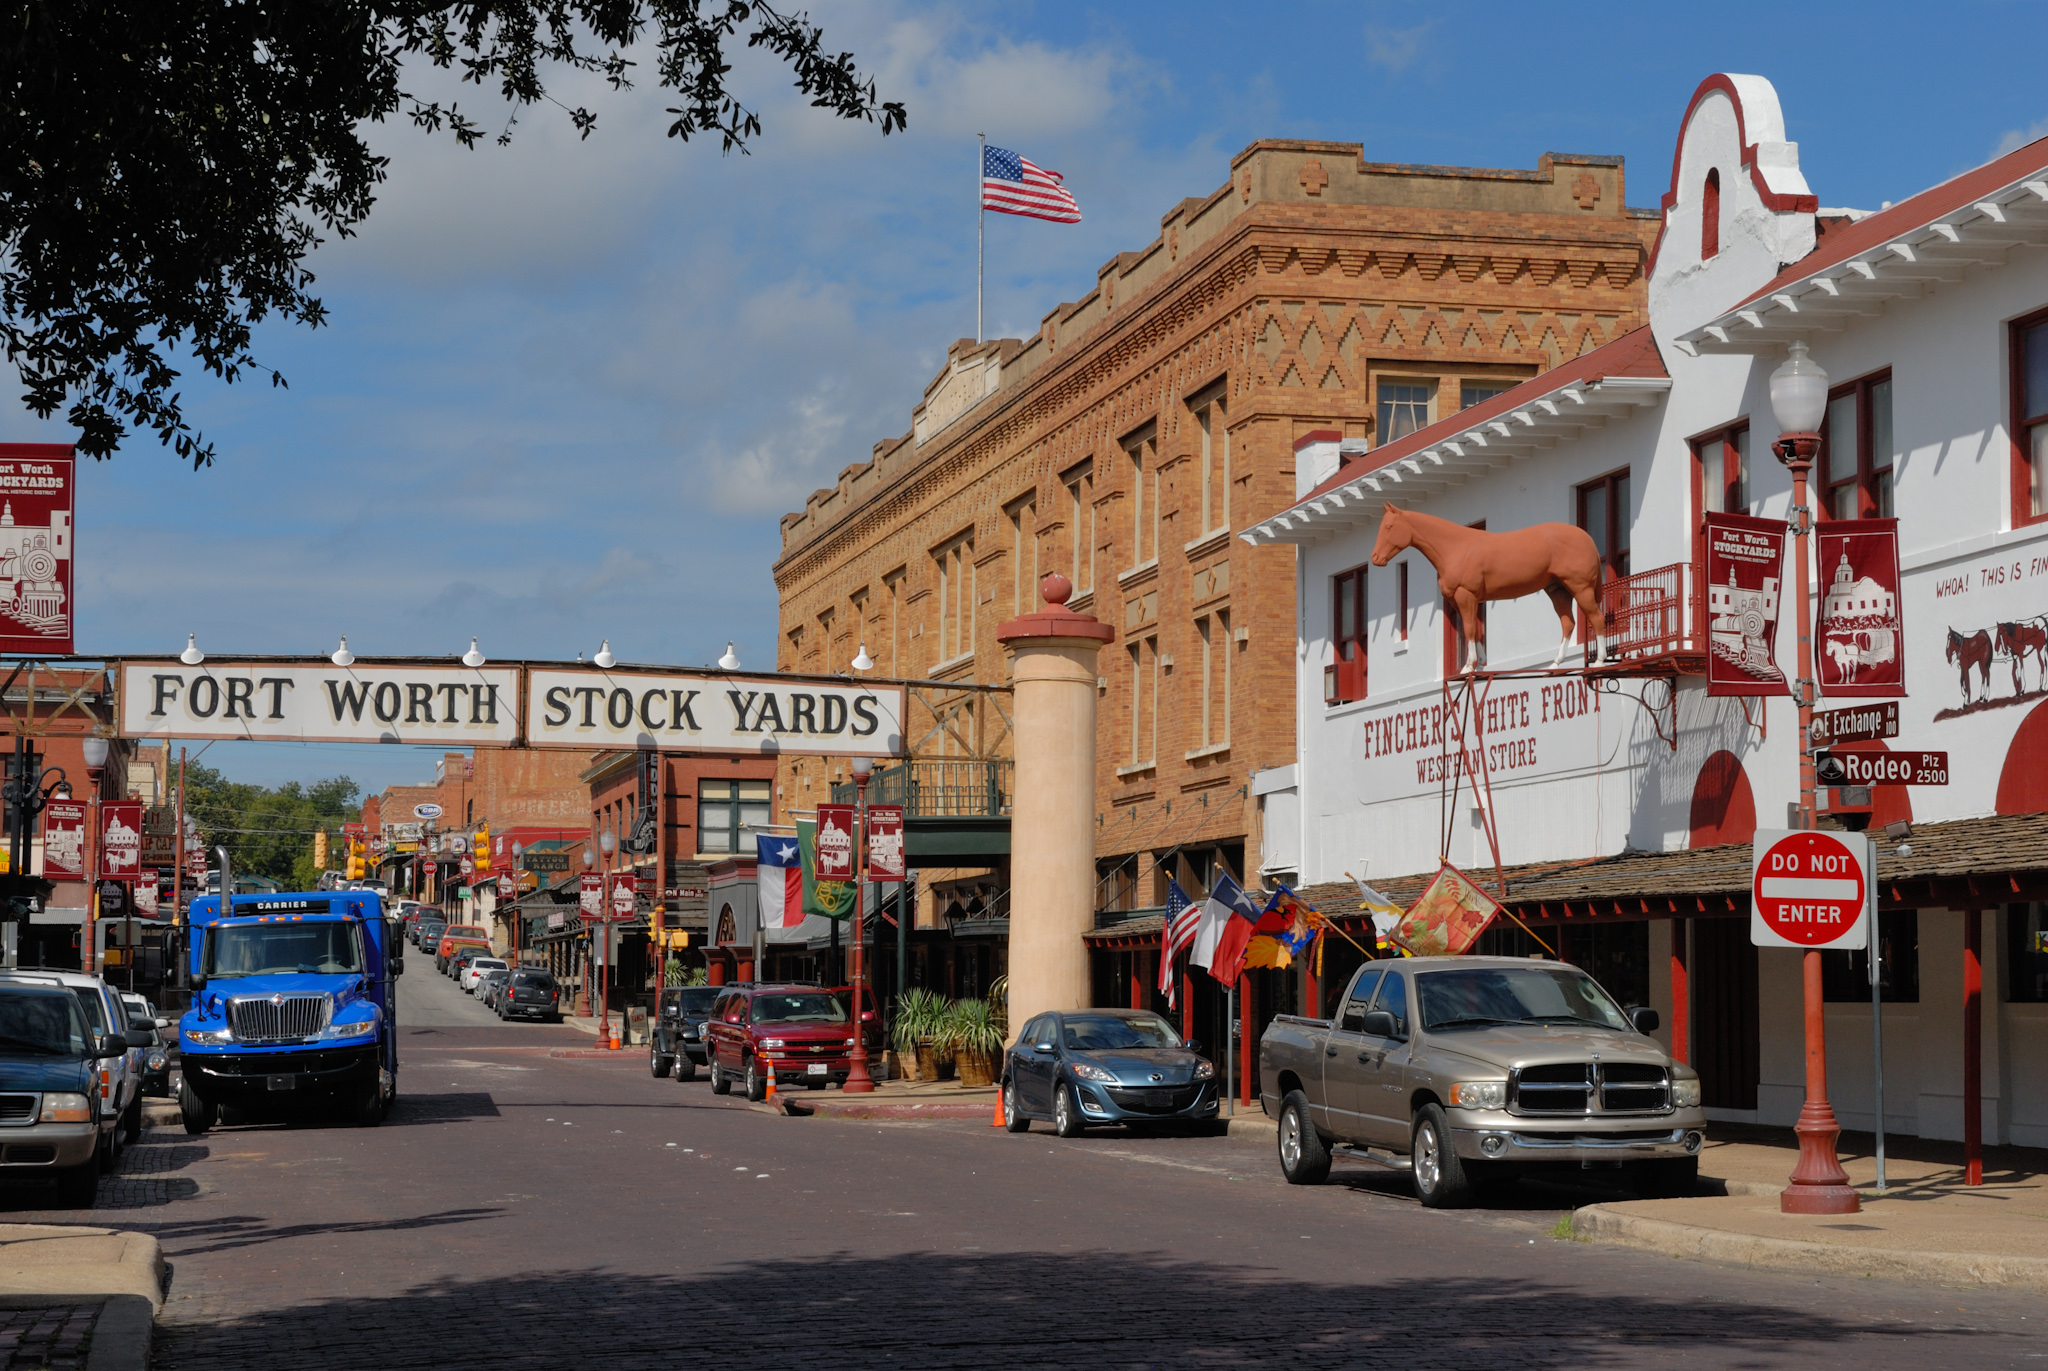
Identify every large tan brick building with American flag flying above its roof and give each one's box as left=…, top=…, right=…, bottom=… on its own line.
left=774, top=141, right=1657, bottom=998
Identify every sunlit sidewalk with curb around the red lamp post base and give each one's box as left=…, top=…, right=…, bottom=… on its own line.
left=1571, top=1125, right=2048, bottom=1291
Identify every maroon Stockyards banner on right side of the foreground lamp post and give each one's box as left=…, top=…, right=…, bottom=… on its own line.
left=1812, top=518, right=1907, bottom=697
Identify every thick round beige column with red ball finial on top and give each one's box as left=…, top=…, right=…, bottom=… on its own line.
left=995, top=572, right=1116, bottom=1035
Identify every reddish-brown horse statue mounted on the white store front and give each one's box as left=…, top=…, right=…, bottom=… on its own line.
left=1372, top=504, right=1608, bottom=676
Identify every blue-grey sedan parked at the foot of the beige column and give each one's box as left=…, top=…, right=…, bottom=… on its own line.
left=1001, top=1008, right=1217, bottom=1137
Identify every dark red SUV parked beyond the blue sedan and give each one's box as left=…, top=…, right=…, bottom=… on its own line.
left=705, top=986, right=872, bottom=1100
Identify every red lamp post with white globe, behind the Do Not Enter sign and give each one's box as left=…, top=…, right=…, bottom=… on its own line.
left=1772, top=342, right=1862, bottom=1213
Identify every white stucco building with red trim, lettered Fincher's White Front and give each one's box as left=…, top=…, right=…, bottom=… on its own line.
left=1241, top=76, right=2048, bottom=1146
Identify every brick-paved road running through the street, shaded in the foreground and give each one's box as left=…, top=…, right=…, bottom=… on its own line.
left=8, top=978, right=2048, bottom=1371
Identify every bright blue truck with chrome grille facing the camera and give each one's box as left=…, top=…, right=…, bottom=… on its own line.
left=178, top=889, right=406, bottom=1133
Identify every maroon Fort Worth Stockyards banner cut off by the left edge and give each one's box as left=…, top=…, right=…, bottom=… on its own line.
left=0, top=443, right=76, bottom=656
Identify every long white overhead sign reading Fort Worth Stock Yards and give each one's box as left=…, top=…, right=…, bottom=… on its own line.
left=119, top=658, right=903, bottom=756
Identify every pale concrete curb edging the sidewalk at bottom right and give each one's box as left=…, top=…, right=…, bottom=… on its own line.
left=1571, top=1205, right=2048, bottom=1293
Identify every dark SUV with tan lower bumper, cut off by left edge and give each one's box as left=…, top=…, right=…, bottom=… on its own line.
left=0, top=978, right=131, bottom=1209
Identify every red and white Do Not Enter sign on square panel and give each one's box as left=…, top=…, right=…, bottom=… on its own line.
left=1749, top=828, right=1878, bottom=949
